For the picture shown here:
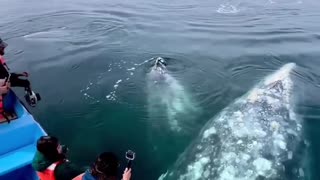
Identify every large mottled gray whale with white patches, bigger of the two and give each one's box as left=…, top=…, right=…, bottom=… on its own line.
left=159, top=63, right=304, bottom=180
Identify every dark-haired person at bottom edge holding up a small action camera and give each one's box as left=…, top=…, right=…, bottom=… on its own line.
left=73, top=152, right=131, bottom=180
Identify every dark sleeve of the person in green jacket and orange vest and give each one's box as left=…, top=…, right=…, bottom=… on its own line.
left=54, top=162, right=84, bottom=180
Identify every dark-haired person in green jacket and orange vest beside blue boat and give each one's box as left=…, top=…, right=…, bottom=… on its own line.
left=32, top=136, right=83, bottom=180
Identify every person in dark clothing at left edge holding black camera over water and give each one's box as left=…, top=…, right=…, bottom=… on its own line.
left=0, top=38, right=38, bottom=106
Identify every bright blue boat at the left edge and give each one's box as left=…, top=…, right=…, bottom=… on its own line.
left=0, top=90, right=46, bottom=180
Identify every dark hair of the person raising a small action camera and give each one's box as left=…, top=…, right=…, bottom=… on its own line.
left=91, top=152, right=120, bottom=180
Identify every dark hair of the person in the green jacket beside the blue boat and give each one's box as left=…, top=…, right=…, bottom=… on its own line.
left=37, top=136, right=65, bottom=162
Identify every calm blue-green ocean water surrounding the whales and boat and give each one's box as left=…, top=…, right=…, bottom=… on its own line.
left=0, top=0, right=320, bottom=180
